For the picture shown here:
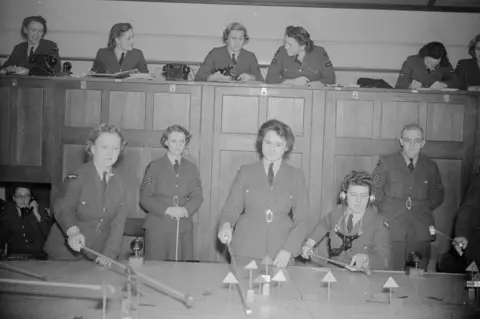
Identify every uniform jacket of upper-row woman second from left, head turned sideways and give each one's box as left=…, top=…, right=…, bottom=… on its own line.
left=92, top=48, right=148, bottom=73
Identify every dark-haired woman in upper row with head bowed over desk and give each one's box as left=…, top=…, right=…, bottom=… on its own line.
left=395, top=42, right=460, bottom=90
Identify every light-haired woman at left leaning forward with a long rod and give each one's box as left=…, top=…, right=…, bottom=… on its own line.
left=44, top=124, right=127, bottom=265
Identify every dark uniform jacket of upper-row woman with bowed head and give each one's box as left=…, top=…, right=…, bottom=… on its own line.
left=395, top=54, right=460, bottom=89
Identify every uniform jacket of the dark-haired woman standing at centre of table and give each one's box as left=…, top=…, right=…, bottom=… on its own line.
left=219, top=161, right=309, bottom=259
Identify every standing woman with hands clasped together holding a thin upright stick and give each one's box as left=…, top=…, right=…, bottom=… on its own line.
left=140, top=125, right=203, bottom=260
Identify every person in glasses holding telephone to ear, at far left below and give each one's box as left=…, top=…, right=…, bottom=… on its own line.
left=0, top=186, right=52, bottom=255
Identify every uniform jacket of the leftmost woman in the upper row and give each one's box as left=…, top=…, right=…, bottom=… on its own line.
left=0, top=39, right=62, bottom=72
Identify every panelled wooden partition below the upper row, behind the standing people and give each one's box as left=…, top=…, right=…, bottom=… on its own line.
left=0, top=77, right=480, bottom=261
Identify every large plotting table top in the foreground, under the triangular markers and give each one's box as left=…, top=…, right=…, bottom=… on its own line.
left=0, top=261, right=475, bottom=319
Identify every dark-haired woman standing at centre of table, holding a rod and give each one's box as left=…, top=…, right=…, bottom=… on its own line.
left=218, top=120, right=309, bottom=267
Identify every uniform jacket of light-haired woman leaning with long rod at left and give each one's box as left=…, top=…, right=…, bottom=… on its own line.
left=44, top=161, right=127, bottom=260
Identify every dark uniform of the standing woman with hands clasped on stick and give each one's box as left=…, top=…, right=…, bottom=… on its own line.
left=140, top=155, right=203, bottom=260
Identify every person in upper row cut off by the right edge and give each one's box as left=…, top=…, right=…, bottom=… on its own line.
left=456, top=34, right=480, bottom=91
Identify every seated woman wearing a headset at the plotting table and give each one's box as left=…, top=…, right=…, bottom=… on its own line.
left=302, top=171, right=390, bottom=270
